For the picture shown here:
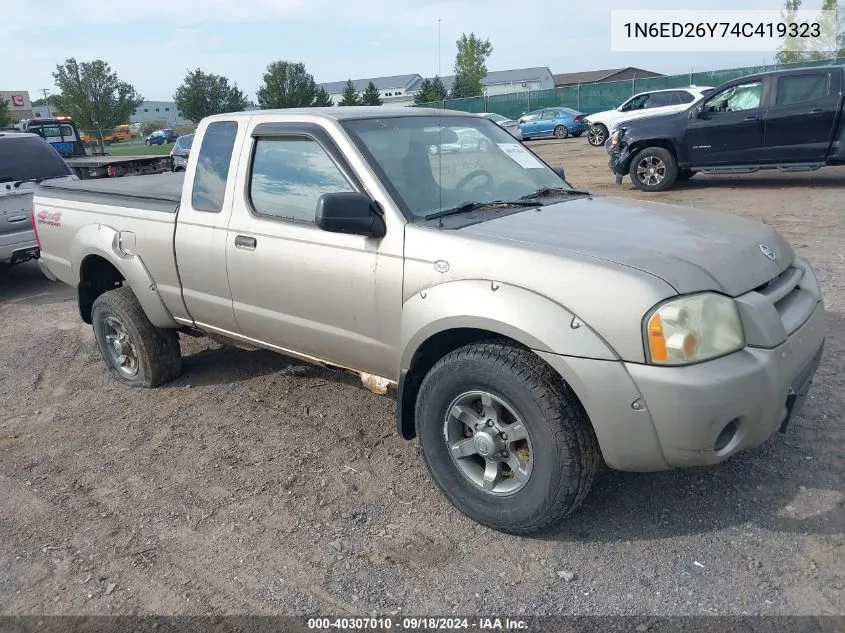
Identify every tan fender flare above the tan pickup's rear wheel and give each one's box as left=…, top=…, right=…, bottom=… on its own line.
left=70, top=224, right=179, bottom=328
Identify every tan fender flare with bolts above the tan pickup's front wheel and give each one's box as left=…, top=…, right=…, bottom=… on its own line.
left=397, top=280, right=618, bottom=373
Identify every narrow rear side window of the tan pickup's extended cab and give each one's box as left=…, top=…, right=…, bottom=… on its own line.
left=191, top=121, right=238, bottom=213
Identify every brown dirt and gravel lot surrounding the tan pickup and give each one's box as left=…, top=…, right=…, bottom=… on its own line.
left=0, top=138, right=845, bottom=615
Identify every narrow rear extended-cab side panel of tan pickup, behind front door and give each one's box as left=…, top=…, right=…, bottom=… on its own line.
left=176, top=119, right=247, bottom=333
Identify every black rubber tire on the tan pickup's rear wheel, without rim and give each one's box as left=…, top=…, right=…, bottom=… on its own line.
left=91, top=286, right=182, bottom=387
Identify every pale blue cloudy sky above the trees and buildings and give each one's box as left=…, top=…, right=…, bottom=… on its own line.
left=0, top=0, right=821, bottom=100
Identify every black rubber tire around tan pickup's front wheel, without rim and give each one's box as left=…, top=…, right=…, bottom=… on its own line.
left=416, top=341, right=601, bottom=534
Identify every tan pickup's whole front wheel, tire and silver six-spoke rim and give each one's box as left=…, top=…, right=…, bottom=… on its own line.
left=416, top=341, right=600, bottom=534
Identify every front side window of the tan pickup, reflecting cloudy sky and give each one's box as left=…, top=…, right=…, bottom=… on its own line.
left=249, top=136, right=353, bottom=222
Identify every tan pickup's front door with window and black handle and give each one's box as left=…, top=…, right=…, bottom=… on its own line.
left=221, top=117, right=403, bottom=376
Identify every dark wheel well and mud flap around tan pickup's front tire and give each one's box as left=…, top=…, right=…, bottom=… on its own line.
left=396, top=328, right=516, bottom=440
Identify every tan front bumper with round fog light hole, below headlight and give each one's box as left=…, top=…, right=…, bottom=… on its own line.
left=539, top=302, right=825, bottom=471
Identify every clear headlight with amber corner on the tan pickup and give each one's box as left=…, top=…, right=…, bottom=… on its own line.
left=644, top=292, right=745, bottom=365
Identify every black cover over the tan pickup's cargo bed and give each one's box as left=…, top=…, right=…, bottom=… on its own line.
left=38, top=172, right=185, bottom=213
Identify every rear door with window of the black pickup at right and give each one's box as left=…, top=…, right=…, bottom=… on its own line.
left=765, top=68, right=841, bottom=163
